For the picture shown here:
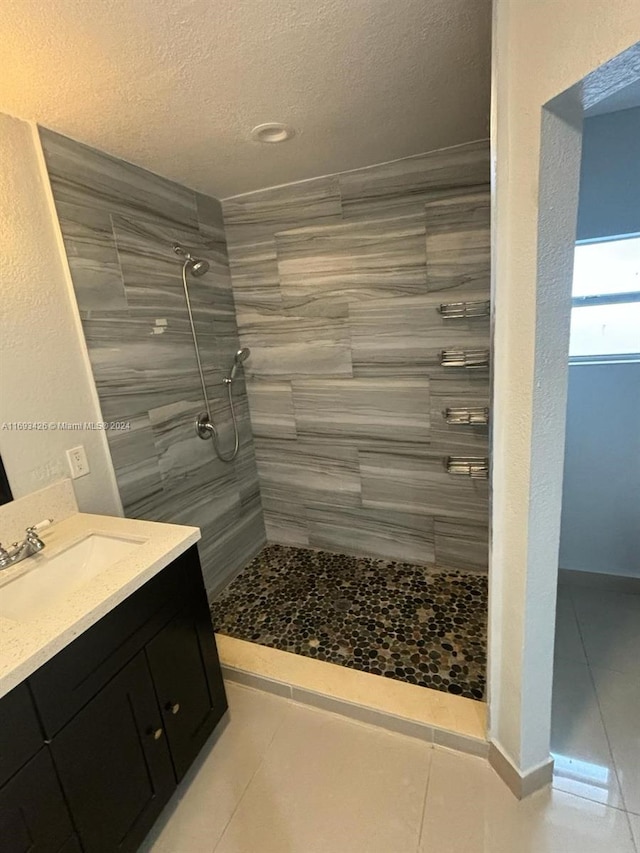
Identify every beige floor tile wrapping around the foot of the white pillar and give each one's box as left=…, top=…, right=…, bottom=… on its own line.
left=418, top=749, right=635, bottom=853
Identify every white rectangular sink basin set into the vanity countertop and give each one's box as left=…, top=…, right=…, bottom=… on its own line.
left=0, top=533, right=146, bottom=621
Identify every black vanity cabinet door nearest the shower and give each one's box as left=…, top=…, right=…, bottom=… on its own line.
left=147, top=594, right=227, bottom=781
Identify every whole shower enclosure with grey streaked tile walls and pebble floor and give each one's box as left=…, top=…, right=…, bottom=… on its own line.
left=41, top=130, right=490, bottom=698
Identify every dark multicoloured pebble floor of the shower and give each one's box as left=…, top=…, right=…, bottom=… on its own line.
left=211, top=545, right=487, bottom=699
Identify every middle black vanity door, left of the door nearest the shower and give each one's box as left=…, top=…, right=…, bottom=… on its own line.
left=51, top=652, right=175, bottom=853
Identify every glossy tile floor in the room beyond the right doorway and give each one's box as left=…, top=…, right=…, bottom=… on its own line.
left=551, top=585, right=640, bottom=812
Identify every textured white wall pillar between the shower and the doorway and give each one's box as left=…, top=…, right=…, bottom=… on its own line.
left=489, top=0, right=640, bottom=773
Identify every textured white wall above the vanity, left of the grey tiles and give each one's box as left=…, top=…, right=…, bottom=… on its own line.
left=0, top=114, right=122, bottom=520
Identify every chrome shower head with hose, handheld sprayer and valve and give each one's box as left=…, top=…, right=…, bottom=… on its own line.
left=173, top=243, right=251, bottom=462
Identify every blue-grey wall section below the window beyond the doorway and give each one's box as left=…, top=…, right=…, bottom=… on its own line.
left=559, top=362, right=640, bottom=577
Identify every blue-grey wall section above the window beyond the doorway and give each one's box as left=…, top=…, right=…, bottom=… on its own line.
left=577, top=107, right=640, bottom=240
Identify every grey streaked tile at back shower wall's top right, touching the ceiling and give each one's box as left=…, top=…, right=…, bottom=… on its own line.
left=338, top=140, right=489, bottom=219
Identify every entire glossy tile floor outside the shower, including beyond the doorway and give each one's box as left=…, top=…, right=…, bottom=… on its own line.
left=142, top=576, right=640, bottom=853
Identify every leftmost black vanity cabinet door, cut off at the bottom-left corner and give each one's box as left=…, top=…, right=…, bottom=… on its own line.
left=0, top=747, right=73, bottom=853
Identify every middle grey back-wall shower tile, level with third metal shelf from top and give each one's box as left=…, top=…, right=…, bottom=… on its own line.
left=292, top=378, right=429, bottom=444
